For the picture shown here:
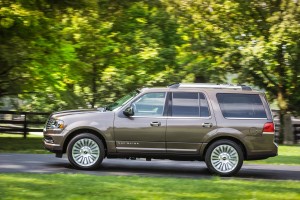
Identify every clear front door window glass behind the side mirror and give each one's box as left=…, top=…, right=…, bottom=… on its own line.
left=132, top=92, right=166, bottom=116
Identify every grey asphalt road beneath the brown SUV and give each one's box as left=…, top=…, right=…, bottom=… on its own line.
left=0, top=154, right=300, bottom=180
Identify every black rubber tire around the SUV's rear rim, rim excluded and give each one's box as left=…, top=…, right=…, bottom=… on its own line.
left=205, top=139, right=244, bottom=176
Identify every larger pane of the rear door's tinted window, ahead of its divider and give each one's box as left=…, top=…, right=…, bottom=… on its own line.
left=172, top=92, right=200, bottom=117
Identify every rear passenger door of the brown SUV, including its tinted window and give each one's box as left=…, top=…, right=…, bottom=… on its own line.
left=166, top=92, right=216, bottom=154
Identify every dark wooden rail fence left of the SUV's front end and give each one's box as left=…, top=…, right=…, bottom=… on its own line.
left=0, top=111, right=50, bottom=138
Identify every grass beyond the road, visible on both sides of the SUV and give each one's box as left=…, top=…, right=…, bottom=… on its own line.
left=0, top=134, right=300, bottom=165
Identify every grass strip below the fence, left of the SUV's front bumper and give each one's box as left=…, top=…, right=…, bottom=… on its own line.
left=0, top=134, right=48, bottom=154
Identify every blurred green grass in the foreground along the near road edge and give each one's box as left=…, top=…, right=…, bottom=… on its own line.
left=0, top=174, right=300, bottom=200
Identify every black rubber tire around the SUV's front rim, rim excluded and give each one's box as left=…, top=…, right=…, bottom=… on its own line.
left=67, top=133, right=105, bottom=170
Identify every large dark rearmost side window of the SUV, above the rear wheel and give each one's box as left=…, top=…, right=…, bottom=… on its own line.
left=217, top=93, right=267, bottom=118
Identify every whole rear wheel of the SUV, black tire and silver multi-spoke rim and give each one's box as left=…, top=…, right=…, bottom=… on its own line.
left=205, top=139, right=244, bottom=176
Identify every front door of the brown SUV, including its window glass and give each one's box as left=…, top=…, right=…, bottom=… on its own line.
left=114, top=92, right=166, bottom=153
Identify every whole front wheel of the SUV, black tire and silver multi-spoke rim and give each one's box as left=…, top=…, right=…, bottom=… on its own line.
left=67, top=133, right=105, bottom=170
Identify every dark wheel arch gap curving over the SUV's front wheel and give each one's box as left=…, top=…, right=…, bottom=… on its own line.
left=63, top=128, right=107, bottom=155
